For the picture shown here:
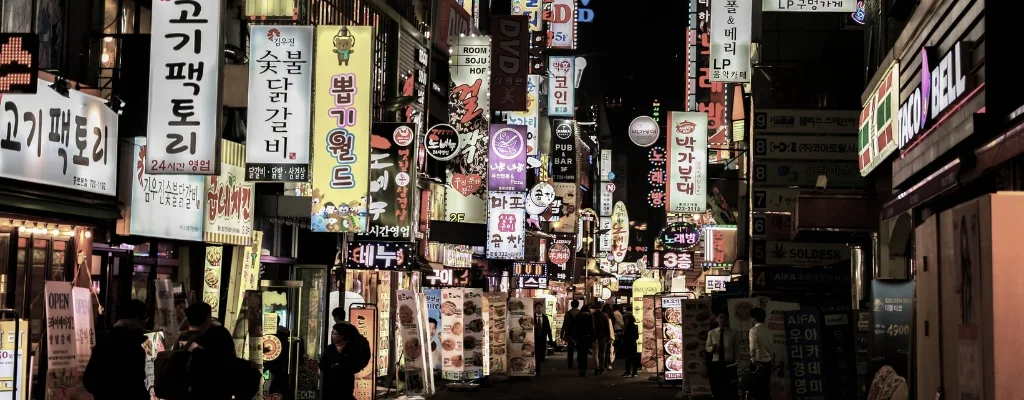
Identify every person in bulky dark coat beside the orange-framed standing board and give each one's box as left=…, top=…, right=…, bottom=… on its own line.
left=319, top=323, right=370, bottom=400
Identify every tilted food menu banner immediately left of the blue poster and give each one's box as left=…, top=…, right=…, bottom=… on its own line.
left=395, top=291, right=429, bottom=395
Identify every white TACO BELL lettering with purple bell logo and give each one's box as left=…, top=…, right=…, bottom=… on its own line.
left=898, top=42, right=971, bottom=150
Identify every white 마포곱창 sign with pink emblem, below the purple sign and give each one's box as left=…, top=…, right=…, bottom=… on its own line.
left=487, top=191, right=526, bottom=260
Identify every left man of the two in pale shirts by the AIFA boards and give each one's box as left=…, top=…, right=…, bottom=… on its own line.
left=705, top=313, right=738, bottom=400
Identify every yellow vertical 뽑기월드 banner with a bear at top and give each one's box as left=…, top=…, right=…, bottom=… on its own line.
left=309, top=26, right=374, bottom=233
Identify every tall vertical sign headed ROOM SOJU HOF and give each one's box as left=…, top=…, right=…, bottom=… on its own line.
left=444, top=36, right=490, bottom=224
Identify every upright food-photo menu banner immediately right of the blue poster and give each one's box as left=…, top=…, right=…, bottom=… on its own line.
left=441, top=287, right=466, bottom=381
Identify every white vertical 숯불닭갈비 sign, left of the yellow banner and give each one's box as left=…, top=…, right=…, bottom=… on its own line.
left=246, top=25, right=313, bottom=182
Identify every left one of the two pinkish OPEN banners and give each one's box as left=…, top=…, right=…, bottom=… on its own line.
left=44, top=281, right=91, bottom=400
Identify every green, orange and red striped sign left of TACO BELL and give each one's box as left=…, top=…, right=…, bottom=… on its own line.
left=857, top=61, right=899, bottom=176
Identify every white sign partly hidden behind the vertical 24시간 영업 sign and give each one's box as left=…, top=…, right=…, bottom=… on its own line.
left=118, top=137, right=207, bottom=241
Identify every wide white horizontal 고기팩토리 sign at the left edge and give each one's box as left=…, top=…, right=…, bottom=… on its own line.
left=0, top=80, right=118, bottom=195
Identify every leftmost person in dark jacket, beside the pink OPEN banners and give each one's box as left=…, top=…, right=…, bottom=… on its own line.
left=82, top=300, right=150, bottom=400
